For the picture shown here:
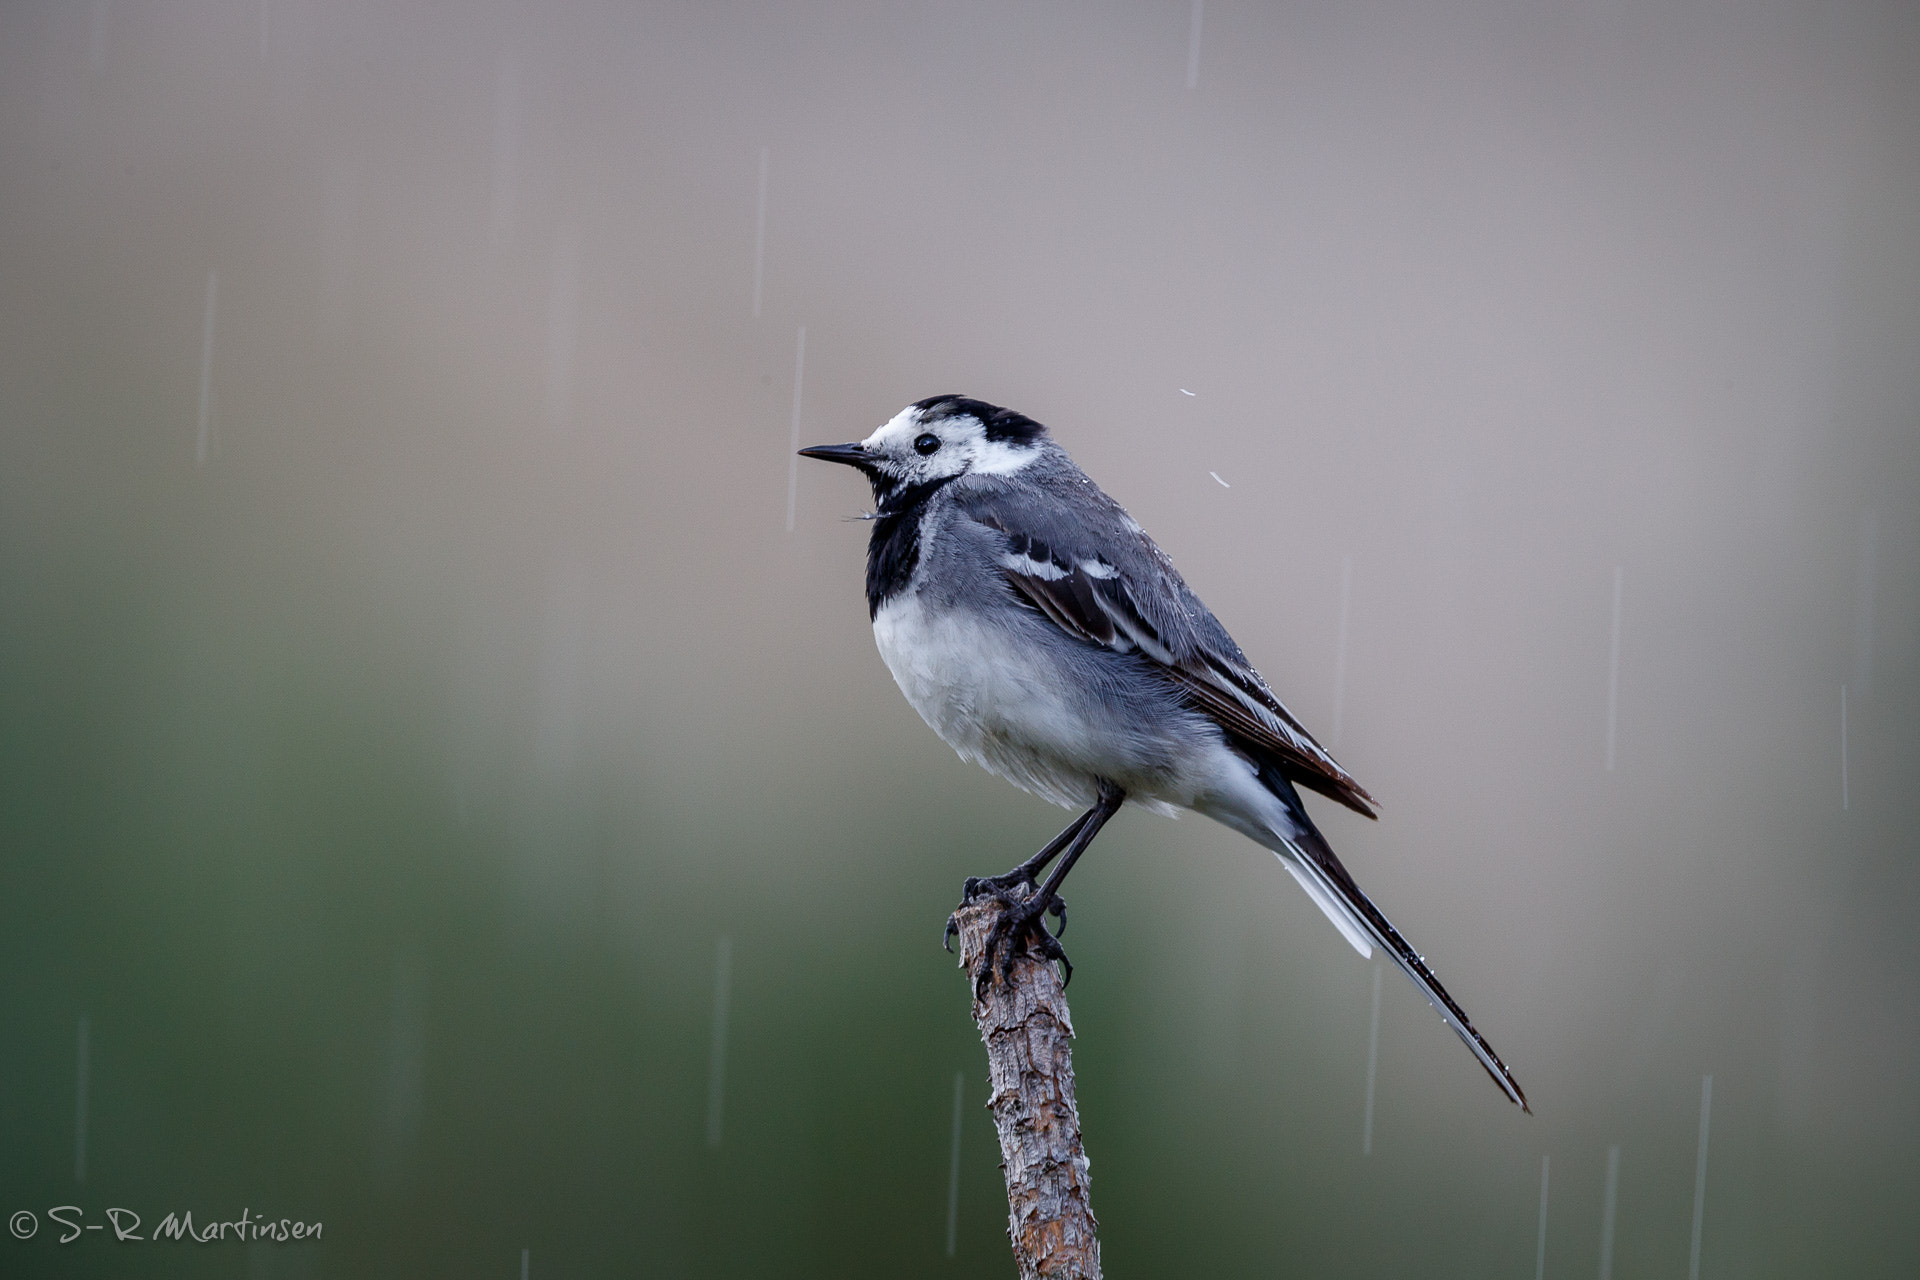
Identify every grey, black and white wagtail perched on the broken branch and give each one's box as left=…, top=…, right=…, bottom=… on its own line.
left=801, top=395, right=1526, bottom=1109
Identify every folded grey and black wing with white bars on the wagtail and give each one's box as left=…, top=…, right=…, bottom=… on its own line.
left=962, top=482, right=1375, bottom=818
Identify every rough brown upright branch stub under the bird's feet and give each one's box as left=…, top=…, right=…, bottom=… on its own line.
left=954, top=885, right=1100, bottom=1280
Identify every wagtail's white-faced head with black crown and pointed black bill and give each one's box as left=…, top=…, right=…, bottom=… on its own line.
left=801, top=395, right=1046, bottom=510
